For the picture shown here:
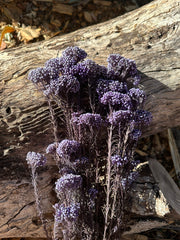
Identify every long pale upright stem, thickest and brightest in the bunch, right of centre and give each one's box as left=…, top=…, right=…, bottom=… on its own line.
left=103, top=125, right=113, bottom=240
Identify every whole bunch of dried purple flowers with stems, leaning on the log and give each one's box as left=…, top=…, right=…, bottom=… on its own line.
left=26, top=46, right=152, bottom=239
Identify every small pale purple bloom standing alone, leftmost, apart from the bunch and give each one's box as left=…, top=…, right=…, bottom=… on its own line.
left=26, top=152, right=46, bottom=168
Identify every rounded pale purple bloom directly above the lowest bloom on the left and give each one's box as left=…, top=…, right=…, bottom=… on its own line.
left=55, top=173, right=82, bottom=194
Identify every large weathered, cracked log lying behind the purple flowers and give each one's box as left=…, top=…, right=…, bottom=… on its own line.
left=0, top=0, right=180, bottom=238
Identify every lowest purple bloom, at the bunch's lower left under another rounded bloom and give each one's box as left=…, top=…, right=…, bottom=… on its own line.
left=54, top=203, right=80, bottom=223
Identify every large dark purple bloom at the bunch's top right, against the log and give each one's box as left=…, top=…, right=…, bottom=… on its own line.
left=107, top=54, right=140, bottom=86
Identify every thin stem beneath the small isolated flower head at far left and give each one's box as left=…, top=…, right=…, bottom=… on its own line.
left=32, top=168, right=52, bottom=240
